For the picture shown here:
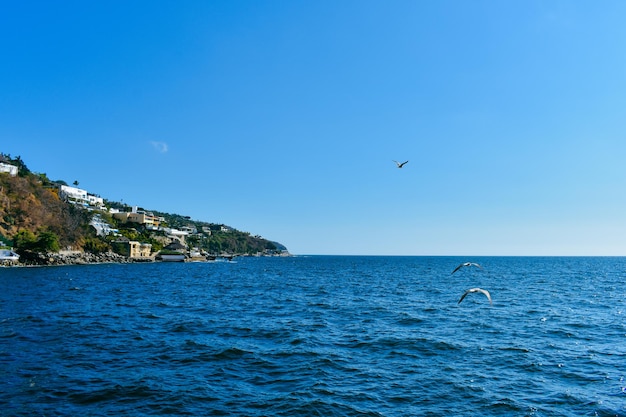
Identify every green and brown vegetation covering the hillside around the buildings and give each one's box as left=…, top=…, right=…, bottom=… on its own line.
left=0, top=154, right=286, bottom=255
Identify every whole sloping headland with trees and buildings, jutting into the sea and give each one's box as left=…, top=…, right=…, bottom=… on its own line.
left=0, top=153, right=290, bottom=265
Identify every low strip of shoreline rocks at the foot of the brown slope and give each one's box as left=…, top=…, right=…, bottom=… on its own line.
left=16, top=252, right=154, bottom=266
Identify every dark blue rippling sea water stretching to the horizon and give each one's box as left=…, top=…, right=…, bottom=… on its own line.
left=0, top=256, right=626, bottom=416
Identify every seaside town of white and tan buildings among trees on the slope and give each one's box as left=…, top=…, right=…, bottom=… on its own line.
left=0, top=155, right=290, bottom=266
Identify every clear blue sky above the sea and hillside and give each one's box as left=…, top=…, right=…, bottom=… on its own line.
left=0, top=0, right=626, bottom=255
